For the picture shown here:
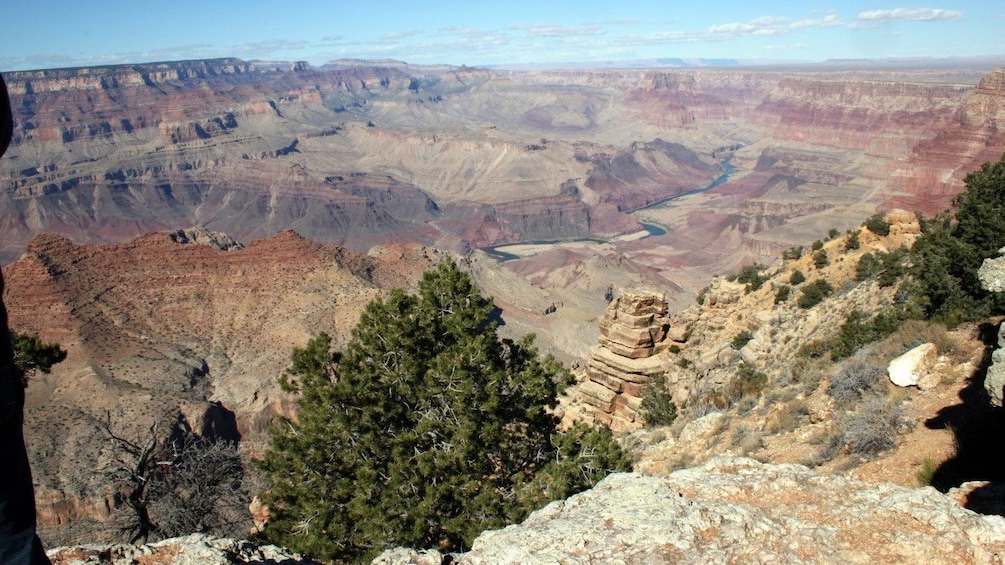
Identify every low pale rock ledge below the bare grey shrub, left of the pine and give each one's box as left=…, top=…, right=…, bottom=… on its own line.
left=48, top=534, right=317, bottom=565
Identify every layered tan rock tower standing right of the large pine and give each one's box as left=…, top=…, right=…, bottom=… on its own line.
left=577, top=290, right=672, bottom=431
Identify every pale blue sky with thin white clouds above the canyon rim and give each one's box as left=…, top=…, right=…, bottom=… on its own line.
left=0, top=0, right=1005, bottom=71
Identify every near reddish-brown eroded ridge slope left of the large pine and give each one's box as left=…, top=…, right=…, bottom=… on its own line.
left=4, top=230, right=438, bottom=526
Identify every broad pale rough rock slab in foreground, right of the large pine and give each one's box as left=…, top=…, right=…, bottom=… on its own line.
left=379, top=457, right=1005, bottom=564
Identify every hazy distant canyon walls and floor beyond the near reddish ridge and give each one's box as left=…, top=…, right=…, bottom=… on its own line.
left=0, top=59, right=1005, bottom=302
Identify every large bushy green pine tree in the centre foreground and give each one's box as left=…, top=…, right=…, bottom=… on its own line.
left=261, top=261, right=630, bottom=561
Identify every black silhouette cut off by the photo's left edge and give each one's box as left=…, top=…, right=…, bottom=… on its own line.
left=0, top=71, right=49, bottom=565
